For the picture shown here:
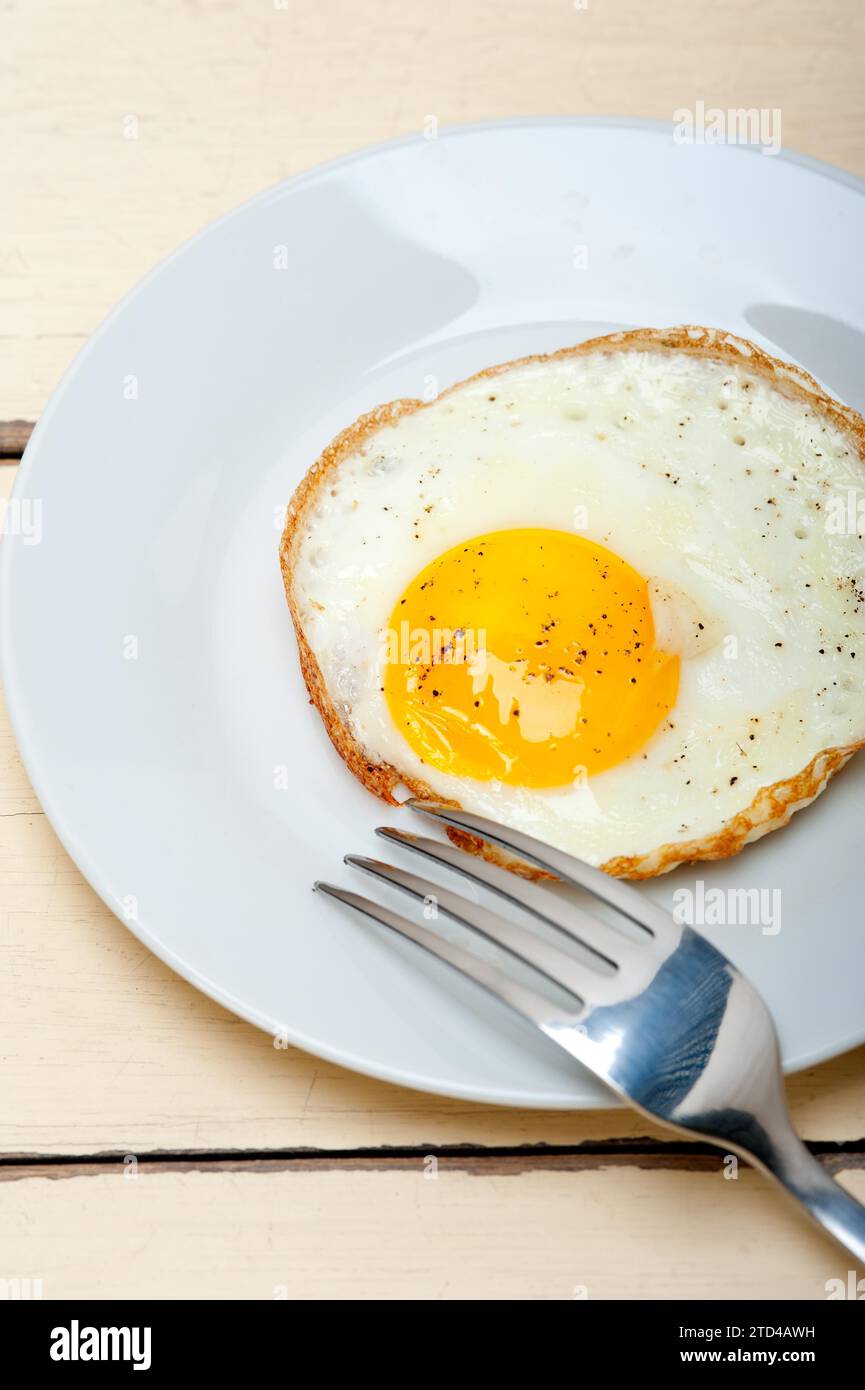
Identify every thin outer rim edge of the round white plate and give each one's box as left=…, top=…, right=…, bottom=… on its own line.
left=0, top=115, right=865, bottom=1113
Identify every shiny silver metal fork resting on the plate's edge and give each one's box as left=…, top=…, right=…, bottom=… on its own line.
left=316, top=801, right=865, bottom=1262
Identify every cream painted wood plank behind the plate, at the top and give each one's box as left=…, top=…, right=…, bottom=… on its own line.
left=6, top=0, right=865, bottom=420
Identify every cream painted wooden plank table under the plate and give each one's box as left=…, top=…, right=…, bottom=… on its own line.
left=0, top=0, right=865, bottom=1298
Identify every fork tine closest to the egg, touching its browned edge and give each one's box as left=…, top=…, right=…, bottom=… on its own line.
left=406, top=796, right=673, bottom=940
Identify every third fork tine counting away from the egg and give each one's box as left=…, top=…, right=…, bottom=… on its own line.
left=345, top=855, right=608, bottom=1001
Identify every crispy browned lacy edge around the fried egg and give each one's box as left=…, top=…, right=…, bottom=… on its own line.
left=280, top=324, right=865, bottom=878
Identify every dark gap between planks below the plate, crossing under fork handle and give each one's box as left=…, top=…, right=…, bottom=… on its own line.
left=0, top=1138, right=865, bottom=1182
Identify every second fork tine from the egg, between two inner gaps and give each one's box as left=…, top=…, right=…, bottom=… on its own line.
left=375, top=826, right=644, bottom=966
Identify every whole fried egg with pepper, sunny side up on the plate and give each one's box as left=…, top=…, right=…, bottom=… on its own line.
left=281, top=328, right=865, bottom=877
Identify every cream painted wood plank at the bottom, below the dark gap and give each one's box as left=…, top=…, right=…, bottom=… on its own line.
left=0, top=1163, right=865, bottom=1301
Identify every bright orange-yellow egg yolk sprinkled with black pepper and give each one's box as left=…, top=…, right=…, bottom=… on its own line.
left=382, top=528, right=679, bottom=787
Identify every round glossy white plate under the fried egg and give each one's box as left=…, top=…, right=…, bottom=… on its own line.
left=1, top=121, right=865, bottom=1106
